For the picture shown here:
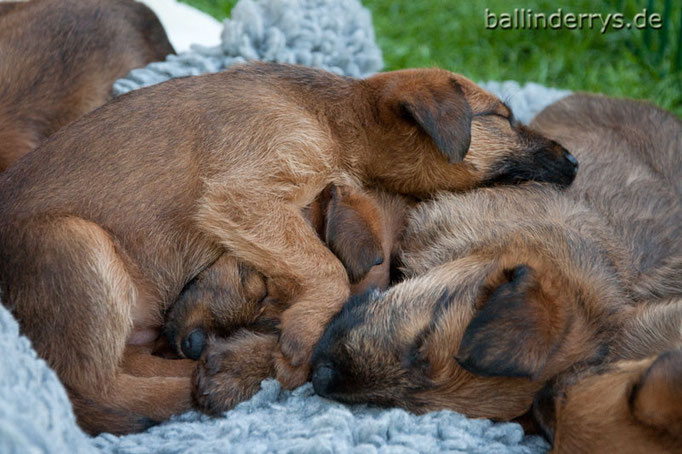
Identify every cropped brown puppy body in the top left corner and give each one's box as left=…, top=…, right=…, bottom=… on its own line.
left=0, top=0, right=174, bottom=172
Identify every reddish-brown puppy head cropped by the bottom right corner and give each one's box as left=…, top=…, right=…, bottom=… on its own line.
left=533, top=350, right=682, bottom=453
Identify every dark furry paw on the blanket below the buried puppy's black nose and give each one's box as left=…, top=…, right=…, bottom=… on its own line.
left=193, top=329, right=277, bottom=415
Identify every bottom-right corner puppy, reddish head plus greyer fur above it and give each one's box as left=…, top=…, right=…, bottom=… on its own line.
left=533, top=298, right=682, bottom=453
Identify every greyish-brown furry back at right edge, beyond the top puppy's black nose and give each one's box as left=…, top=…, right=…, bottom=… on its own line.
left=532, top=94, right=682, bottom=297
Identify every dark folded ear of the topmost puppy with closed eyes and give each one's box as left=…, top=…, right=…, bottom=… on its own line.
left=400, top=81, right=471, bottom=164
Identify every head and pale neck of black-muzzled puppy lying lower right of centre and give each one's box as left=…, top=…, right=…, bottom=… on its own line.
left=312, top=187, right=625, bottom=419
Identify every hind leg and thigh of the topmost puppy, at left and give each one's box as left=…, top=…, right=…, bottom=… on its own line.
left=0, top=217, right=191, bottom=433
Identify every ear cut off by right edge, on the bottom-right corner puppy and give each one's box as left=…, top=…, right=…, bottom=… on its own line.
left=630, top=350, right=682, bottom=439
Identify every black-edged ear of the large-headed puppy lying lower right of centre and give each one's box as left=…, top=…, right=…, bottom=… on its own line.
left=456, top=265, right=555, bottom=379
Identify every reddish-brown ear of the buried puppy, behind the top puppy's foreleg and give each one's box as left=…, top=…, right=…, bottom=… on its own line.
left=324, top=186, right=384, bottom=284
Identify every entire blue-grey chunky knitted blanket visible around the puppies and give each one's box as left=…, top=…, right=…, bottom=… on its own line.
left=0, top=0, right=568, bottom=454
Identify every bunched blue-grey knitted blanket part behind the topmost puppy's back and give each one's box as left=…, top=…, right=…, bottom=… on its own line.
left=114, top=0, right=383, bottom=95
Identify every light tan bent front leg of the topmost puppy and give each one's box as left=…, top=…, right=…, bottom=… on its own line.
left=199, top=199, right=350, bottom=388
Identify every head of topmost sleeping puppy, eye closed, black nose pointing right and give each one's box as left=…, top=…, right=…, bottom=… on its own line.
left=363, top=69, right=577, bottom=192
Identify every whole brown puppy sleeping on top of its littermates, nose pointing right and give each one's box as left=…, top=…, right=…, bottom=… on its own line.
left=0, top=63, right=576, bottom=432
